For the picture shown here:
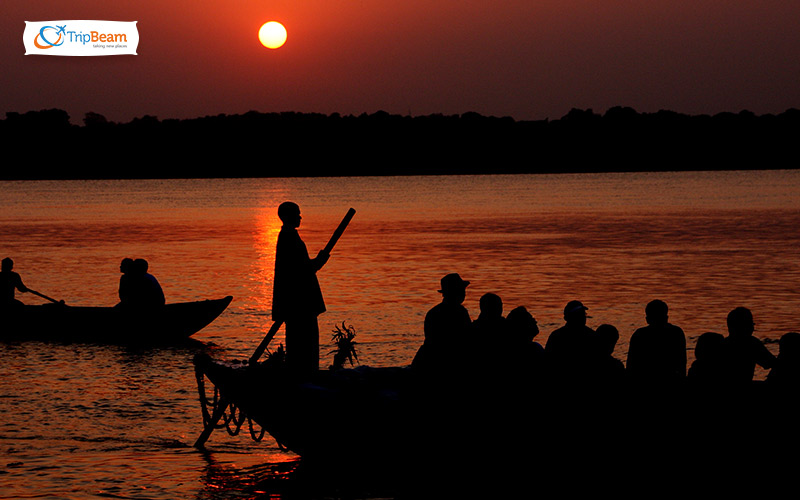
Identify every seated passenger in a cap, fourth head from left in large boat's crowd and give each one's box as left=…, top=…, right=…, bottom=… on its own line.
left=545, top=300, right=602, bottom=383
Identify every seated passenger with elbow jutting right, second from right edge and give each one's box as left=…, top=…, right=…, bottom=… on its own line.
left=722, top=307, right=775, bottom=386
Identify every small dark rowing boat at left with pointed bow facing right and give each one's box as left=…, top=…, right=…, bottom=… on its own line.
left=0, top=296, right=233, bottom=344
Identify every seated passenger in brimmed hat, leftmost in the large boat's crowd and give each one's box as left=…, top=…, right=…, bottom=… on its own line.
left=411, top=273, right=472, bottom=372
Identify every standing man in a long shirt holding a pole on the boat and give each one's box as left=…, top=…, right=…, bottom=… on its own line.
left=272, top=201, right=330, bottom=376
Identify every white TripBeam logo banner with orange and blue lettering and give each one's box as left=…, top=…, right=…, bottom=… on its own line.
left=22, top=20, right=139, bottom=56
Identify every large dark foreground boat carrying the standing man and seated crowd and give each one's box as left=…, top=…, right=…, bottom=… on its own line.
left=194, top=342, right=800, bottom=493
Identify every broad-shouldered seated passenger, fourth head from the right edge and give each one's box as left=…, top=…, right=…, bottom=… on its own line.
left=626, top=300, right=686, bottom=389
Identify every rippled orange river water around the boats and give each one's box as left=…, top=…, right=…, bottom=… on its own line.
left=0, top=171, right=800, bottom=499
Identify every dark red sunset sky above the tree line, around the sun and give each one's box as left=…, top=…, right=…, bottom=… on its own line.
left=0, top=0, right=800, bottom=123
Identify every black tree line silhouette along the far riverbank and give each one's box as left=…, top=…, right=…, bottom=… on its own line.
left=0, top=106, right=800, bottom=179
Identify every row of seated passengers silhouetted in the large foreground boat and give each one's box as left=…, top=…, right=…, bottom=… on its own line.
left=411, top=273, right=800, bottom=391
